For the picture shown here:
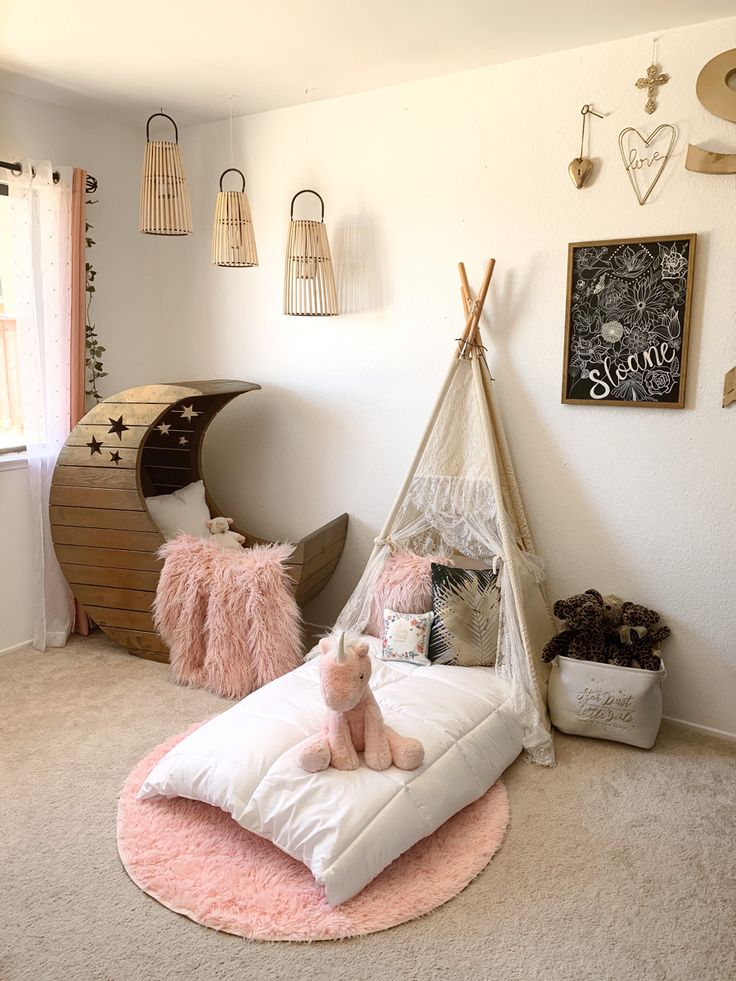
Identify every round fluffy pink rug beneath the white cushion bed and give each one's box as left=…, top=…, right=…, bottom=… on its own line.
left=117, top=726, right=509, bottom=940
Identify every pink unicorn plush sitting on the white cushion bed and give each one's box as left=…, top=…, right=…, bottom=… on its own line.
left=299, top=634, right=424, bottom=773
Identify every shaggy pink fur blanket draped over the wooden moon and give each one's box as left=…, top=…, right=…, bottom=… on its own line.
left=153, top=535, right=301, bottom=698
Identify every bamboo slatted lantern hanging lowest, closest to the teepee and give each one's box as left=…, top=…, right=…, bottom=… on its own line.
left=284, top=189, right=339, bottom=317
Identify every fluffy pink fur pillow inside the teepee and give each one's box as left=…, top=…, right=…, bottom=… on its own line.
left=365, top=552, right=451, bottom=637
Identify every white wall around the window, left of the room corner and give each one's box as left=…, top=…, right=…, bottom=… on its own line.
left=0, top=92, right=162, bottom=651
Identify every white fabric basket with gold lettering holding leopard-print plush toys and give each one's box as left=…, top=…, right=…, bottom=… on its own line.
left=549, top=657, right=667, bottom=749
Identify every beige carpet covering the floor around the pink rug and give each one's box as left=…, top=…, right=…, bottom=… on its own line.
left=0, top=635, right=736, bottom=981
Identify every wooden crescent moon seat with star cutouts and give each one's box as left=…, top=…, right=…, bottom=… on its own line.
left=50, top=379, right=348, bottom=660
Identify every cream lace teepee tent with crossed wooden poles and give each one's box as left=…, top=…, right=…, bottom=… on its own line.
left=335, top=259, right=555, bottom=765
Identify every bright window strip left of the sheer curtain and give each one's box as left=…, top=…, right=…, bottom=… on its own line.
left=0, top=183, right=25, bottom=454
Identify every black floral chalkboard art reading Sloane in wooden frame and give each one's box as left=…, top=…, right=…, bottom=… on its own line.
left=562, top=235, right=697, bottom=409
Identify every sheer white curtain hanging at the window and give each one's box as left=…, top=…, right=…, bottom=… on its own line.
left=8, top=160, right=73, bottom=650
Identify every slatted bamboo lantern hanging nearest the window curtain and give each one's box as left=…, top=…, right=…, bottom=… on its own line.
left=138, top=112, right=192, bottom=235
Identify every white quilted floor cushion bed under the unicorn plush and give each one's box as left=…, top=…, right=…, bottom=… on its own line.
left=138, top=638, right=522, bottom=906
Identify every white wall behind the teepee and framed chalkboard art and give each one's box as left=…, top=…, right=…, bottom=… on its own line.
left=157, top=19, right=736, bottom=731
